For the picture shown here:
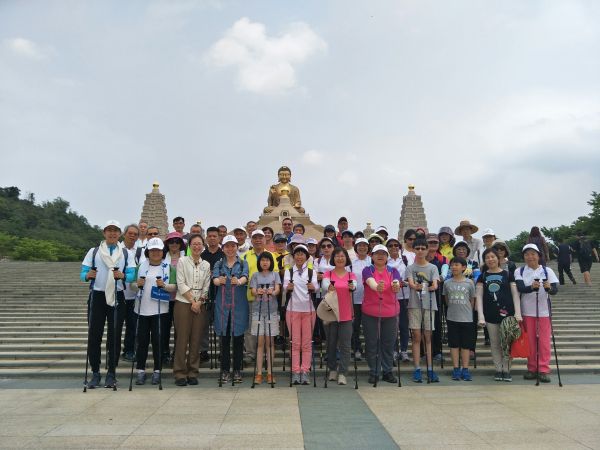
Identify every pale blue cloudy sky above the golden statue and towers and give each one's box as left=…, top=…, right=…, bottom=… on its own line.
left=0, top=0, right=600, bottom=238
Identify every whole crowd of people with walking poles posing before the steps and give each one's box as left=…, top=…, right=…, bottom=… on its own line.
left=80, top=217, right=598, bottom=389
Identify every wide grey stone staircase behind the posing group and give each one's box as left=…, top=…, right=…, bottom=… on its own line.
left=0, top=261, right=600, bottom=378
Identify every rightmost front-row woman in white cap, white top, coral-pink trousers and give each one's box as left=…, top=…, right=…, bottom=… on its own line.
left=515, top=244, right=558, bottom=383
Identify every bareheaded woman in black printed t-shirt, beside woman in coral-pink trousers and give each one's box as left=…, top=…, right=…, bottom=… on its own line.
left=476, top=247, right=523, bottom=381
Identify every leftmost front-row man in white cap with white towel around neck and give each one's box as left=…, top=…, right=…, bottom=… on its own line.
left=79, top=220, right=135, bottom=389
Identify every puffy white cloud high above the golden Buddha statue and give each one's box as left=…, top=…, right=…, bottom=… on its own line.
left=207, top=17, right=327, bottom=94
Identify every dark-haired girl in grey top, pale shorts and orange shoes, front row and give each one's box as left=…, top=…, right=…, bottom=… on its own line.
left=250, top=251, right=281, bottom=384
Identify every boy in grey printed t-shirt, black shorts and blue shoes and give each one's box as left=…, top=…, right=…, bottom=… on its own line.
left=442, top=256, right=475, bottom=381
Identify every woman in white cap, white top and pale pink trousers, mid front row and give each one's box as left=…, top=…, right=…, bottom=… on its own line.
left=283, top=244, right=317, bottom=385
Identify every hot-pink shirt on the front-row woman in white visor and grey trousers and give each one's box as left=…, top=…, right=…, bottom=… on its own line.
left=362, top=266, right=402, bottom=317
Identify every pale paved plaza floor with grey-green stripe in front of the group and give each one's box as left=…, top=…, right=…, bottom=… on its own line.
left=0, top=375, right=600, bottom=449
